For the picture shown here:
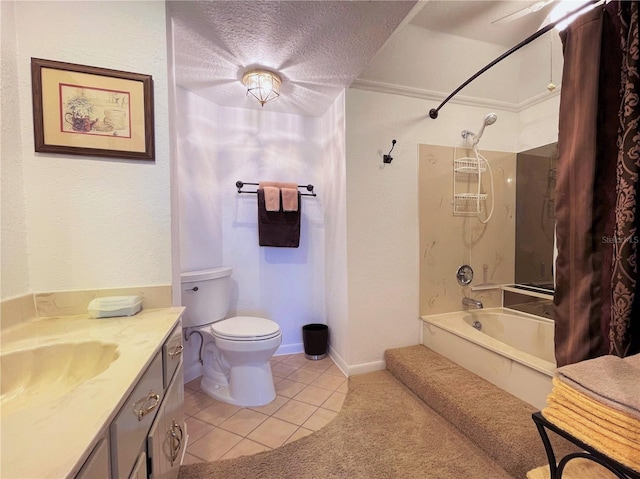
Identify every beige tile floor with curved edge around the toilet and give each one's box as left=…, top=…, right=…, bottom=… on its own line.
left=183, top=353, right=347, bottom=464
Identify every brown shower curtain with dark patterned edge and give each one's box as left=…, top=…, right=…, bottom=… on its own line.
left=554, top=1, right=640, bottom=366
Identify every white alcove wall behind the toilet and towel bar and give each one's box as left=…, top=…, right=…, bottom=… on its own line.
left=177, top=85, right=339, bottom=378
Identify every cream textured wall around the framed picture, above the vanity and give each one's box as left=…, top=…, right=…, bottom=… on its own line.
left=2, top=1, right=171, bottom=298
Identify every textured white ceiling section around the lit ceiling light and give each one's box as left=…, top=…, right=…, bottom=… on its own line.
left=170, top=0, right=416, bottom=116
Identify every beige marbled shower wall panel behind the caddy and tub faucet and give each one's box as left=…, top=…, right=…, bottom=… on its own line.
left=418, top=145, right=516, bottom=315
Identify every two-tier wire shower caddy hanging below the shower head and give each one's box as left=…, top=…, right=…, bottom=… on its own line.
left=453, top=155, right=487, bottom=216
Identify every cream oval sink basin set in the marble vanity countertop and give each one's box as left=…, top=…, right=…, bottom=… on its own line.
left=0, top=341, right=119, bottom=417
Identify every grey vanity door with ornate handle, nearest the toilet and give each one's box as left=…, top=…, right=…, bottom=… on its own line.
left=147, top=364, right=186, bottom=479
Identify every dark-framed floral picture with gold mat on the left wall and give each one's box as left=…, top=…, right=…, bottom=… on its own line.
left=31, top=58, right=155, bottom=160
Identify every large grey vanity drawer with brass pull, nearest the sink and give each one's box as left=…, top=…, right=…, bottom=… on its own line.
left=110, top=352, right=164, bottom=479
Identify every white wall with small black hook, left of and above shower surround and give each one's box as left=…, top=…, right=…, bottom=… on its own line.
left=345, top=88, right=518, bottom=372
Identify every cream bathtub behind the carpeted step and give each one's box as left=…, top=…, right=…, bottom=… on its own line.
left=422, top=308, right=556, bottom=409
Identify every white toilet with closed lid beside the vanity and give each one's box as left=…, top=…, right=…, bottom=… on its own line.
left=181, top=268, right=282, bottom=406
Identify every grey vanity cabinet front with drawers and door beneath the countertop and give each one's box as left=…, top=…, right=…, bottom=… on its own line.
left=104, top=322, right=184, bottom=479
